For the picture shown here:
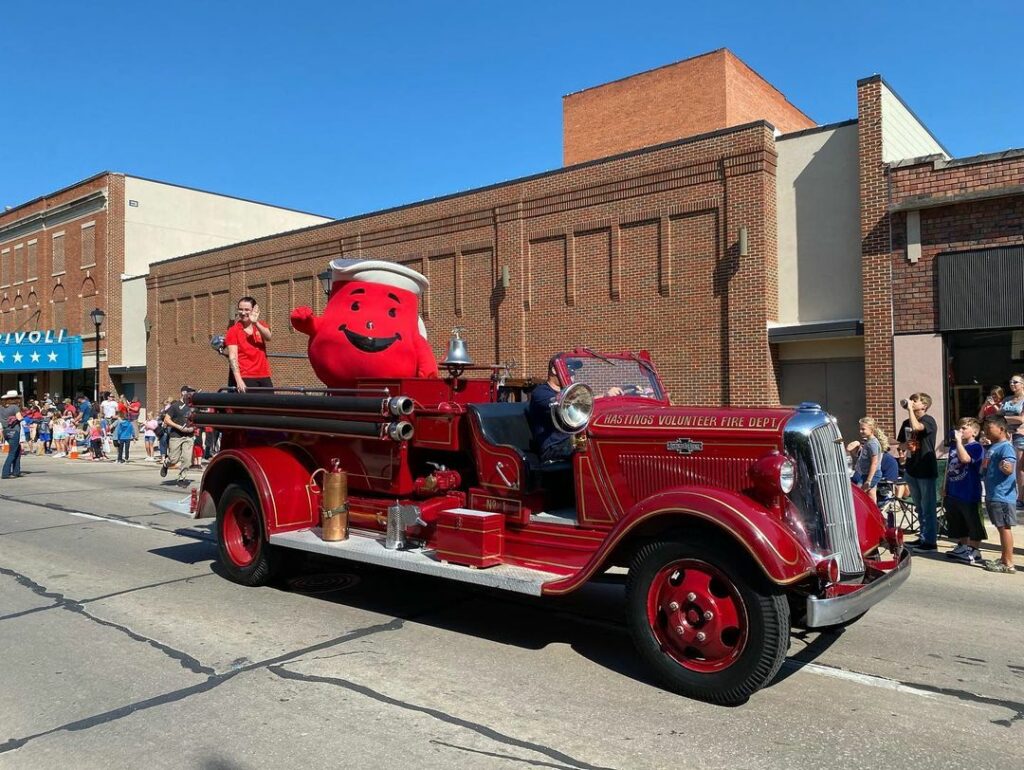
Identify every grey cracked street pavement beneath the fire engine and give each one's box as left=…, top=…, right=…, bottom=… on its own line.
left=0, top=457, right=1024, bottom=770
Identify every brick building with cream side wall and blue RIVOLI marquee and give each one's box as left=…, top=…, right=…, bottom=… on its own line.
left=0, top=172, right=327, bottom=396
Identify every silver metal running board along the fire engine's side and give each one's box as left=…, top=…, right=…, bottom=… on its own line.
left=270, top=527, right=565, bottom=596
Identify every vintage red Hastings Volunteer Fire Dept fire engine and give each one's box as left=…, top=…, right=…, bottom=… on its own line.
left=184, top=348, right=910, bottom=703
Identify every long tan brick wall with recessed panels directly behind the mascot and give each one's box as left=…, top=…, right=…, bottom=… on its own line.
left=147, top=123, right=778, bottom=403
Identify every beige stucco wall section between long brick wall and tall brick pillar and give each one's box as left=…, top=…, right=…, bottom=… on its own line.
left=775, top=124, right=861, bottom=324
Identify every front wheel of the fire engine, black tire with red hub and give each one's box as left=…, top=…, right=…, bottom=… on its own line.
left=626, top=541, right=790, bottom=705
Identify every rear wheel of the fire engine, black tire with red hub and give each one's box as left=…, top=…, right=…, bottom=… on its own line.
left=217, top=484, right=280, bottom=586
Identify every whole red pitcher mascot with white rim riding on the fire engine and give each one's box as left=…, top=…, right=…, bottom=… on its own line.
left=292, top=259, right=437, bottom=388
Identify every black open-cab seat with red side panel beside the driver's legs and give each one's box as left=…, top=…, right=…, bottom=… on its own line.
left=468, top=401, right=572, bottom=491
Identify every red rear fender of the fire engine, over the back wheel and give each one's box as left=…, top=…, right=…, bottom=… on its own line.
left=200, top=446, right=319, bottom=534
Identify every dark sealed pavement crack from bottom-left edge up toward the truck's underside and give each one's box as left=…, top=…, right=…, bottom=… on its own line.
left=0, top=617, right=406, bottom=754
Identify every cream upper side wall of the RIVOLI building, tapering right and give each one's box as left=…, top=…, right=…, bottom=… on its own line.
left=125, top=176, right=329, bottom=275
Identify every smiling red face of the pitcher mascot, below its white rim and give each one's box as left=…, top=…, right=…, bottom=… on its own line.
left=309, top=281, right=420, bottom=382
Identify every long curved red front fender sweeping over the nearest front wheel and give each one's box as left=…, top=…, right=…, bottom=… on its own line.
left=544, top=486, right=814, bottom=594
